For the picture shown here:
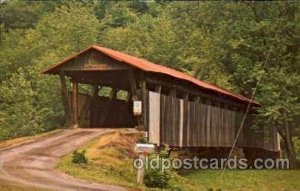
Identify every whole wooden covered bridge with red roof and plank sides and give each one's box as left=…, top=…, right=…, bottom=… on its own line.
left=44, top=45, right=279, bottom=151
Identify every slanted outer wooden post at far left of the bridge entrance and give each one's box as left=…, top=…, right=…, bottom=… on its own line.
left=59, top=73, right=74, bottom=127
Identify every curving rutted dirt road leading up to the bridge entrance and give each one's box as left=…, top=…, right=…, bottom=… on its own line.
left=0, top=129, right=126, bottom=191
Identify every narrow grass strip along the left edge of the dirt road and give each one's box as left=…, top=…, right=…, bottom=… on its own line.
left=0, top=129, right=62, bottom=149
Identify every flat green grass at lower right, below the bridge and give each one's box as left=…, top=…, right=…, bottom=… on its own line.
left=183, top=170, right=300, bottom=191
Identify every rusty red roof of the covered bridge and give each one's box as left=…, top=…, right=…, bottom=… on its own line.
left=43, top=45, right=260, bottom=105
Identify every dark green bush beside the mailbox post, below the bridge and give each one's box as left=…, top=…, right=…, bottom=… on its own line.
left=144, top=151, right=171, bottom=188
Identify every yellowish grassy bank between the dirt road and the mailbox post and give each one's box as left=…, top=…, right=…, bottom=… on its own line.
left=58, top=131, right=196, bottom=190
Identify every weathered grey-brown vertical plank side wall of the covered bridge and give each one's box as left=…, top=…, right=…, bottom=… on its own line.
left=148, top=92, right=270, bottom=151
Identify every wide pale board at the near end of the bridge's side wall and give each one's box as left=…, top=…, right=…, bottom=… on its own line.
left=148, top=91, right=160, bottom=145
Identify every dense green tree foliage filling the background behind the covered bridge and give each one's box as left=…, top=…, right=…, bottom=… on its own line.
left=0, top=0, right=300, bottom=166
